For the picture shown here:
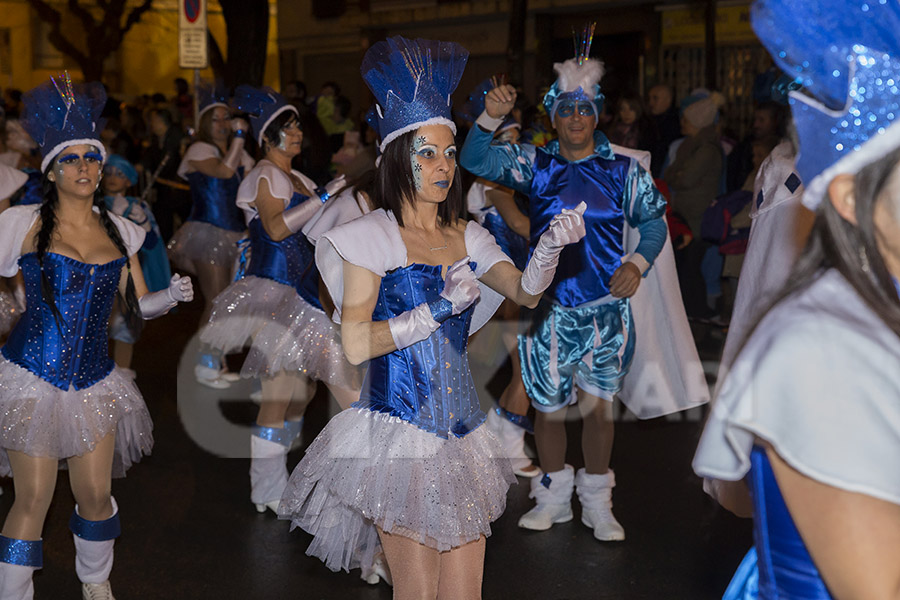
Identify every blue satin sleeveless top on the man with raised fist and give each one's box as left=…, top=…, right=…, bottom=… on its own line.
left=530, top=151, right=631, bottom=307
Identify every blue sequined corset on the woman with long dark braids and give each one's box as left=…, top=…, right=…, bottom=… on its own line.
left=2, top=252, right=126, bottom=390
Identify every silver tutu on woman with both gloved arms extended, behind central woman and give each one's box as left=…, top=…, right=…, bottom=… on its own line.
left=200, top=275, right=361, bottom=389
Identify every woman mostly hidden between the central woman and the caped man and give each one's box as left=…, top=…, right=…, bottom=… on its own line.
left=460, top=76, right=541, bottom=477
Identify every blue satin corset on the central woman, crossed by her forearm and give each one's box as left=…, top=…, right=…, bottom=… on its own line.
left=354, top=264, right=485, bottom=439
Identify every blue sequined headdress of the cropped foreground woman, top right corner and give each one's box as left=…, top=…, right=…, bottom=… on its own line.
left=751, top=0, right=900, bottom=209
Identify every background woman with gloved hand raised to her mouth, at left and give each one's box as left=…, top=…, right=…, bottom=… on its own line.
left=169, top=85, right=253, bottom=388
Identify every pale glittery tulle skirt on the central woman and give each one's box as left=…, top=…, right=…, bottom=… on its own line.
left=278, top=408, right=516, bottom=571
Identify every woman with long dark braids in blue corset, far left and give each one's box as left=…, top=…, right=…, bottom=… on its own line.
left=0, top=75, right=193, bottom=600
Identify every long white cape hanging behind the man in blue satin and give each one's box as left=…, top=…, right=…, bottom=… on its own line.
left=612, top=145, right=709, bottom=419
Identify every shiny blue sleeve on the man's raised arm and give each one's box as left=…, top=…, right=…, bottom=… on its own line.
left=459, top=125, right=535, bottom=194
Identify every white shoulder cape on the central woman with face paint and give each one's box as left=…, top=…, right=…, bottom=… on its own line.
left=316, top=208, right=512, bottom=335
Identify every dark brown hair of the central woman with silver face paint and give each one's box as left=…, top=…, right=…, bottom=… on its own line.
left=374, top=130, right=464, bottom=227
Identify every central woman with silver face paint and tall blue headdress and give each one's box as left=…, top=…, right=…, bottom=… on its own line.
left=279, top=37, right=584, bottom=599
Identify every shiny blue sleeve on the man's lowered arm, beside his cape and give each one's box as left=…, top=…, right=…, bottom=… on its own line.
left=623, top=161, right=669, bottom=265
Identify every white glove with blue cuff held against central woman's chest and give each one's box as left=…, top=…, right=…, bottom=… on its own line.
left=388, top=256, right=481, bottom=350
